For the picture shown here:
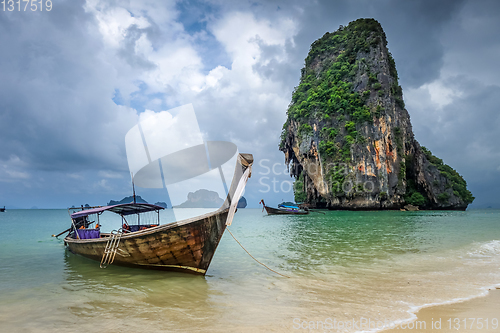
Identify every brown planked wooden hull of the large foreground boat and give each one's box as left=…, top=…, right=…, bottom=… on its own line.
left=64, top=209, right=228, bottom=275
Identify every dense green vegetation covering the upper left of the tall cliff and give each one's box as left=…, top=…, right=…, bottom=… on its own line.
left=280, top=19, right=395, bottom=169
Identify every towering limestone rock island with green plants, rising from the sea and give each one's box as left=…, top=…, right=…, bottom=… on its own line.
left=280, top=19, right=474, bottom=210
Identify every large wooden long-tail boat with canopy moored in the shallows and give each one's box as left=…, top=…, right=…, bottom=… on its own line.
left=64, top=154, right=253, bottom=275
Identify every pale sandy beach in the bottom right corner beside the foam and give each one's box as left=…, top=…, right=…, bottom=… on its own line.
left=384, top=288, right=500, bottom=333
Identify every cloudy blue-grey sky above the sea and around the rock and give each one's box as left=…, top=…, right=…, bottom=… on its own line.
left=0, top=0, right=500, bottom=208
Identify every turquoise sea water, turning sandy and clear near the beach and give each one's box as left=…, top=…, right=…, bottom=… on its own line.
left=0, top=209, right=500, bottom=332
